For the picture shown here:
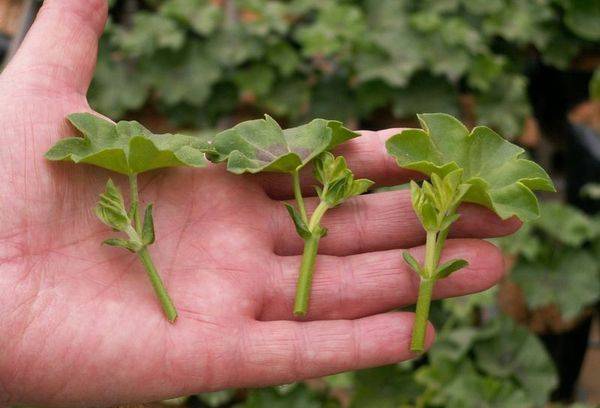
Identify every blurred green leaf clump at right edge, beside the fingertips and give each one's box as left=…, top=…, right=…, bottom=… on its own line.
left=499, top=202, right=600, bottom=321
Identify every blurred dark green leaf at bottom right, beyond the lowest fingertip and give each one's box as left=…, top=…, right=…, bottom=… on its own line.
left=474, top=318, right=558, bottom=406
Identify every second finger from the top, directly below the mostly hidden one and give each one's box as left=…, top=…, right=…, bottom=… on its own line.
left=271, top=190, right=521, bottom=256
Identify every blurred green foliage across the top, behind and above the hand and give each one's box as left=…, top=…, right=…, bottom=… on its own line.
left=90, top=0, right=600, bottom=136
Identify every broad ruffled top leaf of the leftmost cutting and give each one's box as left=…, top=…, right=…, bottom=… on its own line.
left=45, top=113, right=209, bottom=175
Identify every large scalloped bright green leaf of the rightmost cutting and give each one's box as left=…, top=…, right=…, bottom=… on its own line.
left=386, top=113, right=555, bottom=221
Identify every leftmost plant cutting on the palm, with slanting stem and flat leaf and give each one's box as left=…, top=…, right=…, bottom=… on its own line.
left=45, top=113, right=208, bottom=323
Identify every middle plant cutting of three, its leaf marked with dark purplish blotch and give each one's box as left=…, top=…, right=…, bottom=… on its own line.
left=208, top=115, right=373, bottom=316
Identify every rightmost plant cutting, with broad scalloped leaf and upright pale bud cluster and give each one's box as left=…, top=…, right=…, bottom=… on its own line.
left=386, top=113, right=555, bottom=352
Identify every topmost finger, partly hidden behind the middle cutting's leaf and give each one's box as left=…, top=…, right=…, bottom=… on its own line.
left=257, top=128, right=423, bottom=200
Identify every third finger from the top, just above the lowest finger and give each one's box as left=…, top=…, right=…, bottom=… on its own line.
left=260, top=239, right=504, bottom=320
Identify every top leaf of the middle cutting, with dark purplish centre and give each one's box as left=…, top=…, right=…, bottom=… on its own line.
left=209, top=115, right=359, bottom=174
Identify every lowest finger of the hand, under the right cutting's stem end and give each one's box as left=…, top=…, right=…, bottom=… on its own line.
left=238, top=312, right=434, bottom=386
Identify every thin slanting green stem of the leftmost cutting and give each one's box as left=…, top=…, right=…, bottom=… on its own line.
left=129, top=174, right=177, bottom=323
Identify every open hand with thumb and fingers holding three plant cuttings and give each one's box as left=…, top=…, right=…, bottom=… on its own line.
left=0, top=0, right=517, bottom=407
